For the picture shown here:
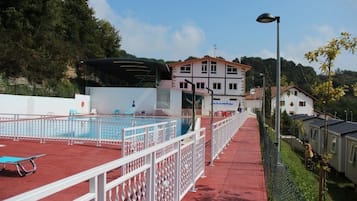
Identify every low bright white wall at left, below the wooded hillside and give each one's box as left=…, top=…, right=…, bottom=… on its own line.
left=0, top=94, right=90, bottom=115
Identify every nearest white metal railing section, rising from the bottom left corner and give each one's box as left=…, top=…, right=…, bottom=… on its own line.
left=7, top=128, right=205, bottom=201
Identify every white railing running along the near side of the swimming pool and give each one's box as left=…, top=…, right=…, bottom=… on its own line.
left=0, top=114, right=176, bottom=146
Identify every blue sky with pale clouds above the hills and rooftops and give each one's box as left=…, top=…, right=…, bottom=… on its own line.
left=89, top=0, right=357, bottom=73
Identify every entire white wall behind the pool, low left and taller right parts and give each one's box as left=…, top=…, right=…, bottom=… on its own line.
left=0, top=87, right=182, bottom=116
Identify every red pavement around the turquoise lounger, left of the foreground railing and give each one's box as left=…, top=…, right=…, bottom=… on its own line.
left=0, top=139, right=121, bottom=201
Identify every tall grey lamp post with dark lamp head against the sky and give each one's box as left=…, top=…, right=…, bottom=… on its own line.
left=257, top=13, right=281, bottom=153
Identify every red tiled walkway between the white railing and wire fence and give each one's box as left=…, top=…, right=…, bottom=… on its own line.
left=183, top=117, right=267, bottom=201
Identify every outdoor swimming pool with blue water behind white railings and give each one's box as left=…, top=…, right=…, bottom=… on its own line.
left=0, top=115, right=191, bottom=141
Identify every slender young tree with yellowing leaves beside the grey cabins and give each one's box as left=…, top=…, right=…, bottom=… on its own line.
left=305, top=32, right=357, bottom=201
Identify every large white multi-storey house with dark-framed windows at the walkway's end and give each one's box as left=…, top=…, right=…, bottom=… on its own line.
left=169, top=56, right=251, bottom=115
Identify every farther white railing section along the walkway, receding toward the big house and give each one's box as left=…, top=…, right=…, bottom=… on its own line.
left=210, top=112, right=248, bottom=165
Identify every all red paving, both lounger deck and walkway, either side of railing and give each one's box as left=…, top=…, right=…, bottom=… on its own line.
left=0, top=117, right=267, bottom=201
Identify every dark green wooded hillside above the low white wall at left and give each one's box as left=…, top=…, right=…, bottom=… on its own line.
left=0, top=0, right=132, bottom=96
